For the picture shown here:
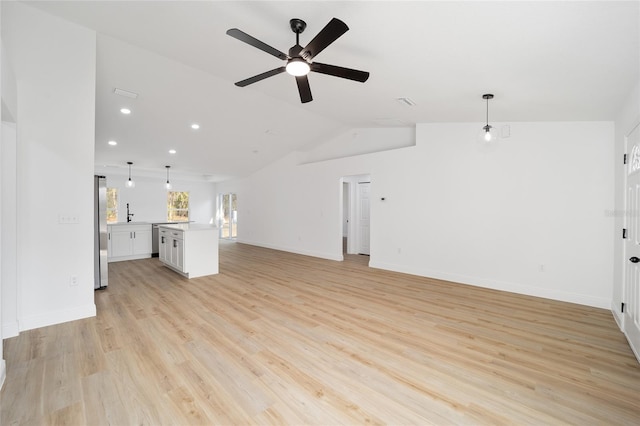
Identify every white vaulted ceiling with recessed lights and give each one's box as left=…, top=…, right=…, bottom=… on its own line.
left=28, top=1, right=640, bottom=181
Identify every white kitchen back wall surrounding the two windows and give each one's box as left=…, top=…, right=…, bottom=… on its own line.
left=98, top=169, right=216, bottom=223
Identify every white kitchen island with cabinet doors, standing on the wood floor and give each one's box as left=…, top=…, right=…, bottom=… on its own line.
left=158, top=223, right=218, bottom=278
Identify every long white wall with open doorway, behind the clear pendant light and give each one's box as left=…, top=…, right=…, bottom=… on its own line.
left=218, top=122, right=614, bottom=308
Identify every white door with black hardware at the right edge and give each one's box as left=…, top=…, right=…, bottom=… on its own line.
left=623, top=121, right=640, bottom=360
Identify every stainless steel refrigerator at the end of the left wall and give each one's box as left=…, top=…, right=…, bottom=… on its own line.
left=93, top=176, right=109, bottom=289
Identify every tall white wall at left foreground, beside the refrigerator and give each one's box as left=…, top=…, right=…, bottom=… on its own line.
left=2, top=2, right=96, bottom=330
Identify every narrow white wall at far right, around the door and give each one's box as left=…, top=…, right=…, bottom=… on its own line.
left=611, top=78, right=640, bottom=326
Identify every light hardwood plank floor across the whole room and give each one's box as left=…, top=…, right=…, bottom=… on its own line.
left=0, top=242, right=640, bottom=426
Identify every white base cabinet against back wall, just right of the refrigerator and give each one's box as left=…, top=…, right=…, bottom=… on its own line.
left=107, top=222, right=151, bottom=262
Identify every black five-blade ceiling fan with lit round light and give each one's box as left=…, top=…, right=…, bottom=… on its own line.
left=227, top=18, right=369, bottom=103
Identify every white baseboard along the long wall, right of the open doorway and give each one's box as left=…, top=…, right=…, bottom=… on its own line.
left=369, top=260, right=611, bottom=309
